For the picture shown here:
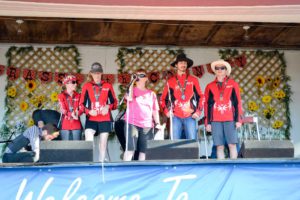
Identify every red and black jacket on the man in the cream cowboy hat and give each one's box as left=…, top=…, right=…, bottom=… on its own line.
left=204, top=77, right=243, bottom=124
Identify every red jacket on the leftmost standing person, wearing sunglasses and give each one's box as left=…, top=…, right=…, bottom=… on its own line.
left=58, top=91, right=82, bottom=130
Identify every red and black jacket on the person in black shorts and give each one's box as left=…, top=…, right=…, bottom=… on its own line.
left=79, top=81, right=118, bottom=122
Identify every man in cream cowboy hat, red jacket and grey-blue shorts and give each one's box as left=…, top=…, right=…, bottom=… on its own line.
left=204, top=60, right=242, bottom=159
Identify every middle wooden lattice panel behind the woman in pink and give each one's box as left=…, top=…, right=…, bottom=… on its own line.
left=123, top=49, right=176, bottom=93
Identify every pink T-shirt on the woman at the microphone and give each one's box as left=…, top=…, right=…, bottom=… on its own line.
left=125, top=87, right=159, bottom=128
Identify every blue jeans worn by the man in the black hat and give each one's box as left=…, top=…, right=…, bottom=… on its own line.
left=172, top=116, right=197, bottom=140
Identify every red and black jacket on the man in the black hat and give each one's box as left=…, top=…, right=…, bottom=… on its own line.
left=160, top=74, right=204, bottom=118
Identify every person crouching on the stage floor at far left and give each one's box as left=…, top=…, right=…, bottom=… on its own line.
left=2, top=121, right=59, bottom=163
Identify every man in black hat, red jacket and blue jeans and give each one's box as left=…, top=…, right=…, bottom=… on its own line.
left=160, top=53, right=204, bottom=139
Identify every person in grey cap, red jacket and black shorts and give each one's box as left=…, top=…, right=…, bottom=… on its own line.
left=79, top=62, right=118, bottom=162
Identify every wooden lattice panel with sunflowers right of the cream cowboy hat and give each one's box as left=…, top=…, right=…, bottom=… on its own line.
left=231, top=51, right=287, bottom=137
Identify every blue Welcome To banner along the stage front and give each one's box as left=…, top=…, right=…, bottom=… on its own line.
left=0, top=158, right=300, bottom=200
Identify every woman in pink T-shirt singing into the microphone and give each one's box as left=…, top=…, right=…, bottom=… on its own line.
left=123, top=69, right=161, bottom=161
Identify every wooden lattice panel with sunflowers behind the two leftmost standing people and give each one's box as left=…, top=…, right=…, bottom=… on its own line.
left=6, top=48, right=78, bottom=126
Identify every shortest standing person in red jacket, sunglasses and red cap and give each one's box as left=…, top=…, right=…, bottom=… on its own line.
left=58, top=75, right=82, bottom=140
